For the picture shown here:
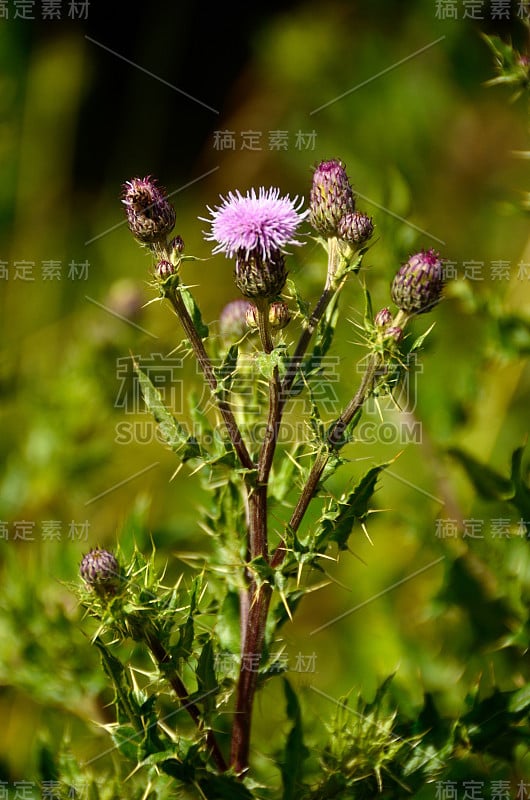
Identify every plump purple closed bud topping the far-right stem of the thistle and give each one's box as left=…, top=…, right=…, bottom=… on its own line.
left=391, top=250, right=444, bottom=314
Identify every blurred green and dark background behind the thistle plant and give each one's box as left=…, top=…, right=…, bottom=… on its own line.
left=0, top=0, right=530, bottom=797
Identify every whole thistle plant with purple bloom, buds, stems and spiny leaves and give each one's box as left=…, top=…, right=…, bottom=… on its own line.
left=76, top=159, right=443, bottom=798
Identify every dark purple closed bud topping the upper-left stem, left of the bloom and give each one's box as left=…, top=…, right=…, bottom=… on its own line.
left=122, top=175, right=175, bottom=244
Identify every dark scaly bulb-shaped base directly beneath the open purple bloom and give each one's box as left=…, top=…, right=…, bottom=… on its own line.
left=234, top=250, right=287, bottom=299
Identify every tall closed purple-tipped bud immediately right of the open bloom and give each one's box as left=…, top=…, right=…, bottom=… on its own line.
left=309, top=159, right=355, bottom=236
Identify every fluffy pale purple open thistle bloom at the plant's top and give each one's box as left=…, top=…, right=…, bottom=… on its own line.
left=200, top=187, right=309, bottom=260
